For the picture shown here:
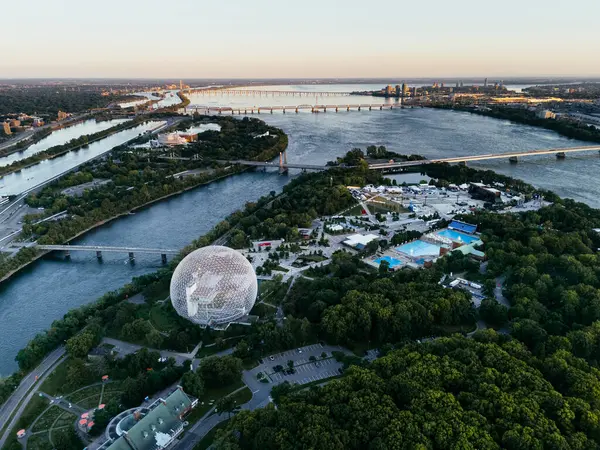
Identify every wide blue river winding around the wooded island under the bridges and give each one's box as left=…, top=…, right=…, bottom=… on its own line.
left=0, top=86, right=600, bottom=375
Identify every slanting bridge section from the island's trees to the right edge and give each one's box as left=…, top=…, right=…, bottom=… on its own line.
left=369, top=145, right=600, bottom=170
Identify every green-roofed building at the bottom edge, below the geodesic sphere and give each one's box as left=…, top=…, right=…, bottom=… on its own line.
left=99, top=386, right=198, bottom=450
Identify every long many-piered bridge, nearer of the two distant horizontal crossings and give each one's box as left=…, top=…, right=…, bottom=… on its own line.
left=186, top=102, right=404, bottom=115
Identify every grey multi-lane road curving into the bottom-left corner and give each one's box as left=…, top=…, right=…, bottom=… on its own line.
left=0, top=347, right=65, bottom=448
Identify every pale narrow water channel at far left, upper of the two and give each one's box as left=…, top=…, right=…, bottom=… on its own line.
left=0, top=119, right=127, bottom=167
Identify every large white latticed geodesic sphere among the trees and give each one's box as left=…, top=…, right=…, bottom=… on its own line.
left=171, top=245, right=258, bottom=329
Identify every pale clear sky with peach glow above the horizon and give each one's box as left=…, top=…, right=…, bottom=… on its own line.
left=0, top=0, right=600, bottom=78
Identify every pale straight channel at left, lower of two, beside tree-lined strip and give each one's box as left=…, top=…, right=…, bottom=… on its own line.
left=0, top=121, right=163, bottom=195
